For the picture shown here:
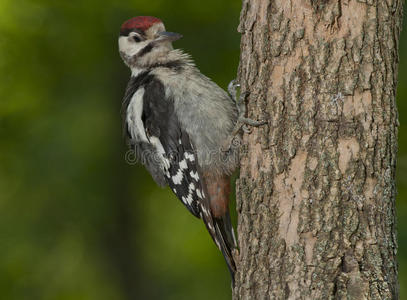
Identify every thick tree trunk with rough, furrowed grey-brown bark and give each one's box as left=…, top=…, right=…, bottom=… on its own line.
left=233, top=0, right=402, bottom=300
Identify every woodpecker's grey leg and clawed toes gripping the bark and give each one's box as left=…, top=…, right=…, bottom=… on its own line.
left=223, top=80, right=267, bottom=151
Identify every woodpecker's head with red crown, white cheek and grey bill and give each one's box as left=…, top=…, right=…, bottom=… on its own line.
left=119, top=16, right=182, bottom=67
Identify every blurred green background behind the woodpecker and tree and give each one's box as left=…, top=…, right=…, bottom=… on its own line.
left=0, top=0, right=407, bottom=300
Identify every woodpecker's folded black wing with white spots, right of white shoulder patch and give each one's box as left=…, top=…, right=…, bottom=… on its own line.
left=142, top=76, right=205, bottom=217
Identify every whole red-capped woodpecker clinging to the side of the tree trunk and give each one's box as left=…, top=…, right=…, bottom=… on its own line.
left=119, top=16, right=263, bottom=281
